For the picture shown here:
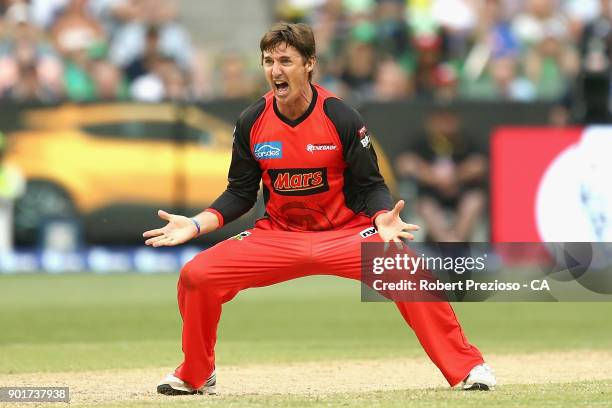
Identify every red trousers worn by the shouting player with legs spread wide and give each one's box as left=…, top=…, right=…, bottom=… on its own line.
left=175, top=216, right=483, bottom=388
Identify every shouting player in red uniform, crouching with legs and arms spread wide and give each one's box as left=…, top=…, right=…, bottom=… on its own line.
left=143, top=23, right=495, bottom=395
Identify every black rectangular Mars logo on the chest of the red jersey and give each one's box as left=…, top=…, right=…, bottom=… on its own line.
left=268, top=167, right=329, bottom=196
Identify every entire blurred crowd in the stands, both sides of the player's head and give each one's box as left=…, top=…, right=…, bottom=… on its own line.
left=0, top=0, right=612, bottom=103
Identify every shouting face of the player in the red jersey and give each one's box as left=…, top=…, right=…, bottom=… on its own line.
left=262, top=43, right=314, bottom=103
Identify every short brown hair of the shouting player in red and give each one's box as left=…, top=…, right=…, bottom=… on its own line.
left=259, top=21, right=316, bottom=80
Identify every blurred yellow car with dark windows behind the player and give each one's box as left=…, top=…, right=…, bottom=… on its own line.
left=7, top=103, right=395, bottom=244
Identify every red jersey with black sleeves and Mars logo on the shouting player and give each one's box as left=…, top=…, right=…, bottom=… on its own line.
left=209, top=85, right=392, bottom=231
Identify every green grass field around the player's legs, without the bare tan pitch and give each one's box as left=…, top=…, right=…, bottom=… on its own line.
left=0, top=274, right=612, bottom=407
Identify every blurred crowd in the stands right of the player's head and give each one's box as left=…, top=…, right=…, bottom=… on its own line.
left=278, top=0, right=612, bottom=101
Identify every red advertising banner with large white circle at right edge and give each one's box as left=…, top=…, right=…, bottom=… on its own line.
left=491, top=126, right=612, bottom=242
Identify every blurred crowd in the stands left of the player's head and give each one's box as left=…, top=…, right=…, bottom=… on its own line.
left=0, top=0, right=218, bottom=102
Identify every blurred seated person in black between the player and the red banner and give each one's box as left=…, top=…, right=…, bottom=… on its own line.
left=397, top=109, right=486, bottom=242
